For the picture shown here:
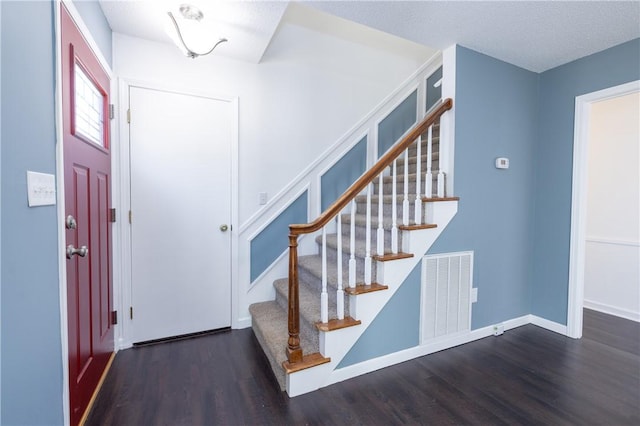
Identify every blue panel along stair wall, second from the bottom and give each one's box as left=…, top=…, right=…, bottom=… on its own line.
left=320, top=136, right=367, bottom=211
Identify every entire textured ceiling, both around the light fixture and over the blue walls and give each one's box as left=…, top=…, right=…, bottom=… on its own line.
left=100, top=0, right=640, bottom=72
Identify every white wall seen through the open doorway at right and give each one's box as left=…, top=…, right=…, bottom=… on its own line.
left=584, top=93, right=640, bottom=321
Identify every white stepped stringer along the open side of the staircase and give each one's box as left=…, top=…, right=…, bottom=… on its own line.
left=286, top=200, right=458, bottom=397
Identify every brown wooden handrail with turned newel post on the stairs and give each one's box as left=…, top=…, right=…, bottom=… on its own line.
left=287, top=98, right=453, bottom=364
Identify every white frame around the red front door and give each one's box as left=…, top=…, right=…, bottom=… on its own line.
left=53, top=0, right=118, bottom=425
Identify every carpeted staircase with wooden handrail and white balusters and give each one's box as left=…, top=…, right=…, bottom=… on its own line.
left=249, top=100, right=457, bottom=396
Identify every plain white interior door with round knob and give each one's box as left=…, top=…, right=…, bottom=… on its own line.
left=129, top=86, right=233, bottom=342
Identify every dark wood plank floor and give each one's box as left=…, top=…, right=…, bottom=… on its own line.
left=86, top=310, right=640, bottom=425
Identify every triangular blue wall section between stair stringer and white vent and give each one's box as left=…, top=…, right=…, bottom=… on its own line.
left=337, top=262, right=422, bottom=368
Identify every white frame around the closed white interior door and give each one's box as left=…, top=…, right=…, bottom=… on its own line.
left=113, top=76, right=241, bottom=349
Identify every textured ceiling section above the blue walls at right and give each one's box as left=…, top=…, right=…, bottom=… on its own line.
left=308, top=1, right=640, bottom=72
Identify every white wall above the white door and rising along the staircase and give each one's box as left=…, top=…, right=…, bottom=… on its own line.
left=114, top=5, right=435, bottom=225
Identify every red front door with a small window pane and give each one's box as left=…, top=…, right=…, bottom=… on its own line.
left=60, top=3, right=113, bottom=425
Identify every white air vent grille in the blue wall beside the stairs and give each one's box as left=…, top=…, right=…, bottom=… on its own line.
left=420, top=252, right=473, bottom=342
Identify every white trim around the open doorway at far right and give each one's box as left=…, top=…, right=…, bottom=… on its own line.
left=567, top=80, right=640, bottom=339
